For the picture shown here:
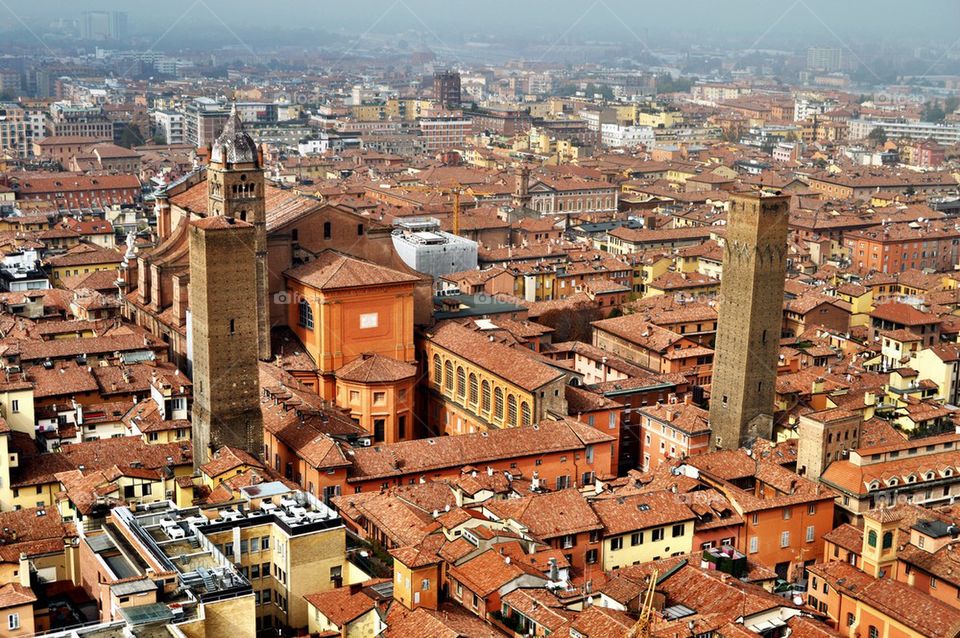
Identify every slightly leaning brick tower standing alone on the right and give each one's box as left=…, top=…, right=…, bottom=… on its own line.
left=710, top=194, right=790, bottom=449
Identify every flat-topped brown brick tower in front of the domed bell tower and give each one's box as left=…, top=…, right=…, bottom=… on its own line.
left=189, top=215, right=263, bottom=467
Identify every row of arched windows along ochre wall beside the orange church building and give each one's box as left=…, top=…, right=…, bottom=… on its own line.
left=433, top=354, right=533, bottom=426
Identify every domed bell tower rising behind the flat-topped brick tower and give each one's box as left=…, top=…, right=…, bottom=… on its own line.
left=207, top=107, right=270, bottom=361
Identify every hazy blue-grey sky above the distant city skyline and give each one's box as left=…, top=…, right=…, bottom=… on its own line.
left=0, top=0, right=960, bottom=48
